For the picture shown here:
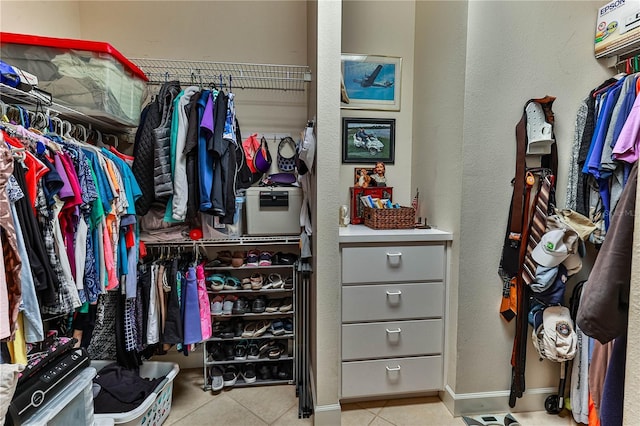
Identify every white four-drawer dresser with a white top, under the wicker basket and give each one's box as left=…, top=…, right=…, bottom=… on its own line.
left=340, top=225, right=452, bottom=398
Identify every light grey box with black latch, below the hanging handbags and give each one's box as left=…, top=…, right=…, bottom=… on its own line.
left=246, top=186, right=302, bottom=235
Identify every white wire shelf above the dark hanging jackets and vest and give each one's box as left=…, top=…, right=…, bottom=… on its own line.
left=130, top=58, right=311, bottom=92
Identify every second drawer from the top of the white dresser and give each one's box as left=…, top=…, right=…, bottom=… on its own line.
left=342, top=282, right=444, bottom=322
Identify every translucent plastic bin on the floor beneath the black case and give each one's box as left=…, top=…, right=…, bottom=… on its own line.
left=22, top=367, right=96, bottom=426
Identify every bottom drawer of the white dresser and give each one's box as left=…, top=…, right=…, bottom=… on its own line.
left=342, top=356, right=443, bottom=398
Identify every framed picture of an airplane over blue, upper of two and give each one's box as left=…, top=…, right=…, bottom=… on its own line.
left=340, top=54, right=402, bottom=111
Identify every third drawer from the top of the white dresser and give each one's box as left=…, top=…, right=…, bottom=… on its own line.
left=342, top=319, right=443, bottom=361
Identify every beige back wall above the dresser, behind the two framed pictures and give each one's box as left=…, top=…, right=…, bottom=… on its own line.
left=339, top=0, right=415, bottom=206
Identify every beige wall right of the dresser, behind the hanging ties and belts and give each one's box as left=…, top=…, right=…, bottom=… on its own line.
left=413, top=1, right=610, bottom=412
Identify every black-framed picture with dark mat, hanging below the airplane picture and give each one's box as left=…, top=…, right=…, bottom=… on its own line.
left=342, top=117, right=396, bottom=164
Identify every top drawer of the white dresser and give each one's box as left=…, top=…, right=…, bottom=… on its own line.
left=342, top=244, right=444, bottom=284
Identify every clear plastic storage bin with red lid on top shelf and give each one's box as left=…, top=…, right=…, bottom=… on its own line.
left=0, top=32, right=148, bottom=126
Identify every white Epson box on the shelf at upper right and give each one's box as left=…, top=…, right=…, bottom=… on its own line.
left=595, top=0, right=640, bottom=58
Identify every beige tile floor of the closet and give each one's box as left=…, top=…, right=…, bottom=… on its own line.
left=165, top=368, right=576, bottom=426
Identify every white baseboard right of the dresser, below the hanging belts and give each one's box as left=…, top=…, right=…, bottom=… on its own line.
left=440, top=385, right=558, bottom=417
